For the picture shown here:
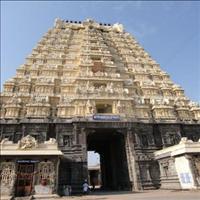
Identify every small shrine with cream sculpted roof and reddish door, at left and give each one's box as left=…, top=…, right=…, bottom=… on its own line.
left=0, top=135, right=63, bottom=199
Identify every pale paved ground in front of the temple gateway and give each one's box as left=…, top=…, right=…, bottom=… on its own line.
left=59, top=190, right=200, bottom=200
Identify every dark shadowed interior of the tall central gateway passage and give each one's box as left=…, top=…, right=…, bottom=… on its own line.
left=87, top=129, right=130, bottom=190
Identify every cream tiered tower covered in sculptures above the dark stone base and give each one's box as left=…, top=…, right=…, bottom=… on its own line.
left=1, top=19, right=200, bottom=122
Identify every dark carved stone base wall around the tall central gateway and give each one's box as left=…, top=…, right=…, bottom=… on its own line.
left=1, top=122, right=200, bottom=192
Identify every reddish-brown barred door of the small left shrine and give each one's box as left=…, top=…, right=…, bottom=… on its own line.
left=16, top=163, right=34, bottom=197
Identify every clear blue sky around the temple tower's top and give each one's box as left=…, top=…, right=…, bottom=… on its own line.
left=1, top=1, right=200, bottom=101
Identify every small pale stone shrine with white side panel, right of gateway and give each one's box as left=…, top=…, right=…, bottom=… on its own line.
left=154, top=138, right=200, bottom=189
